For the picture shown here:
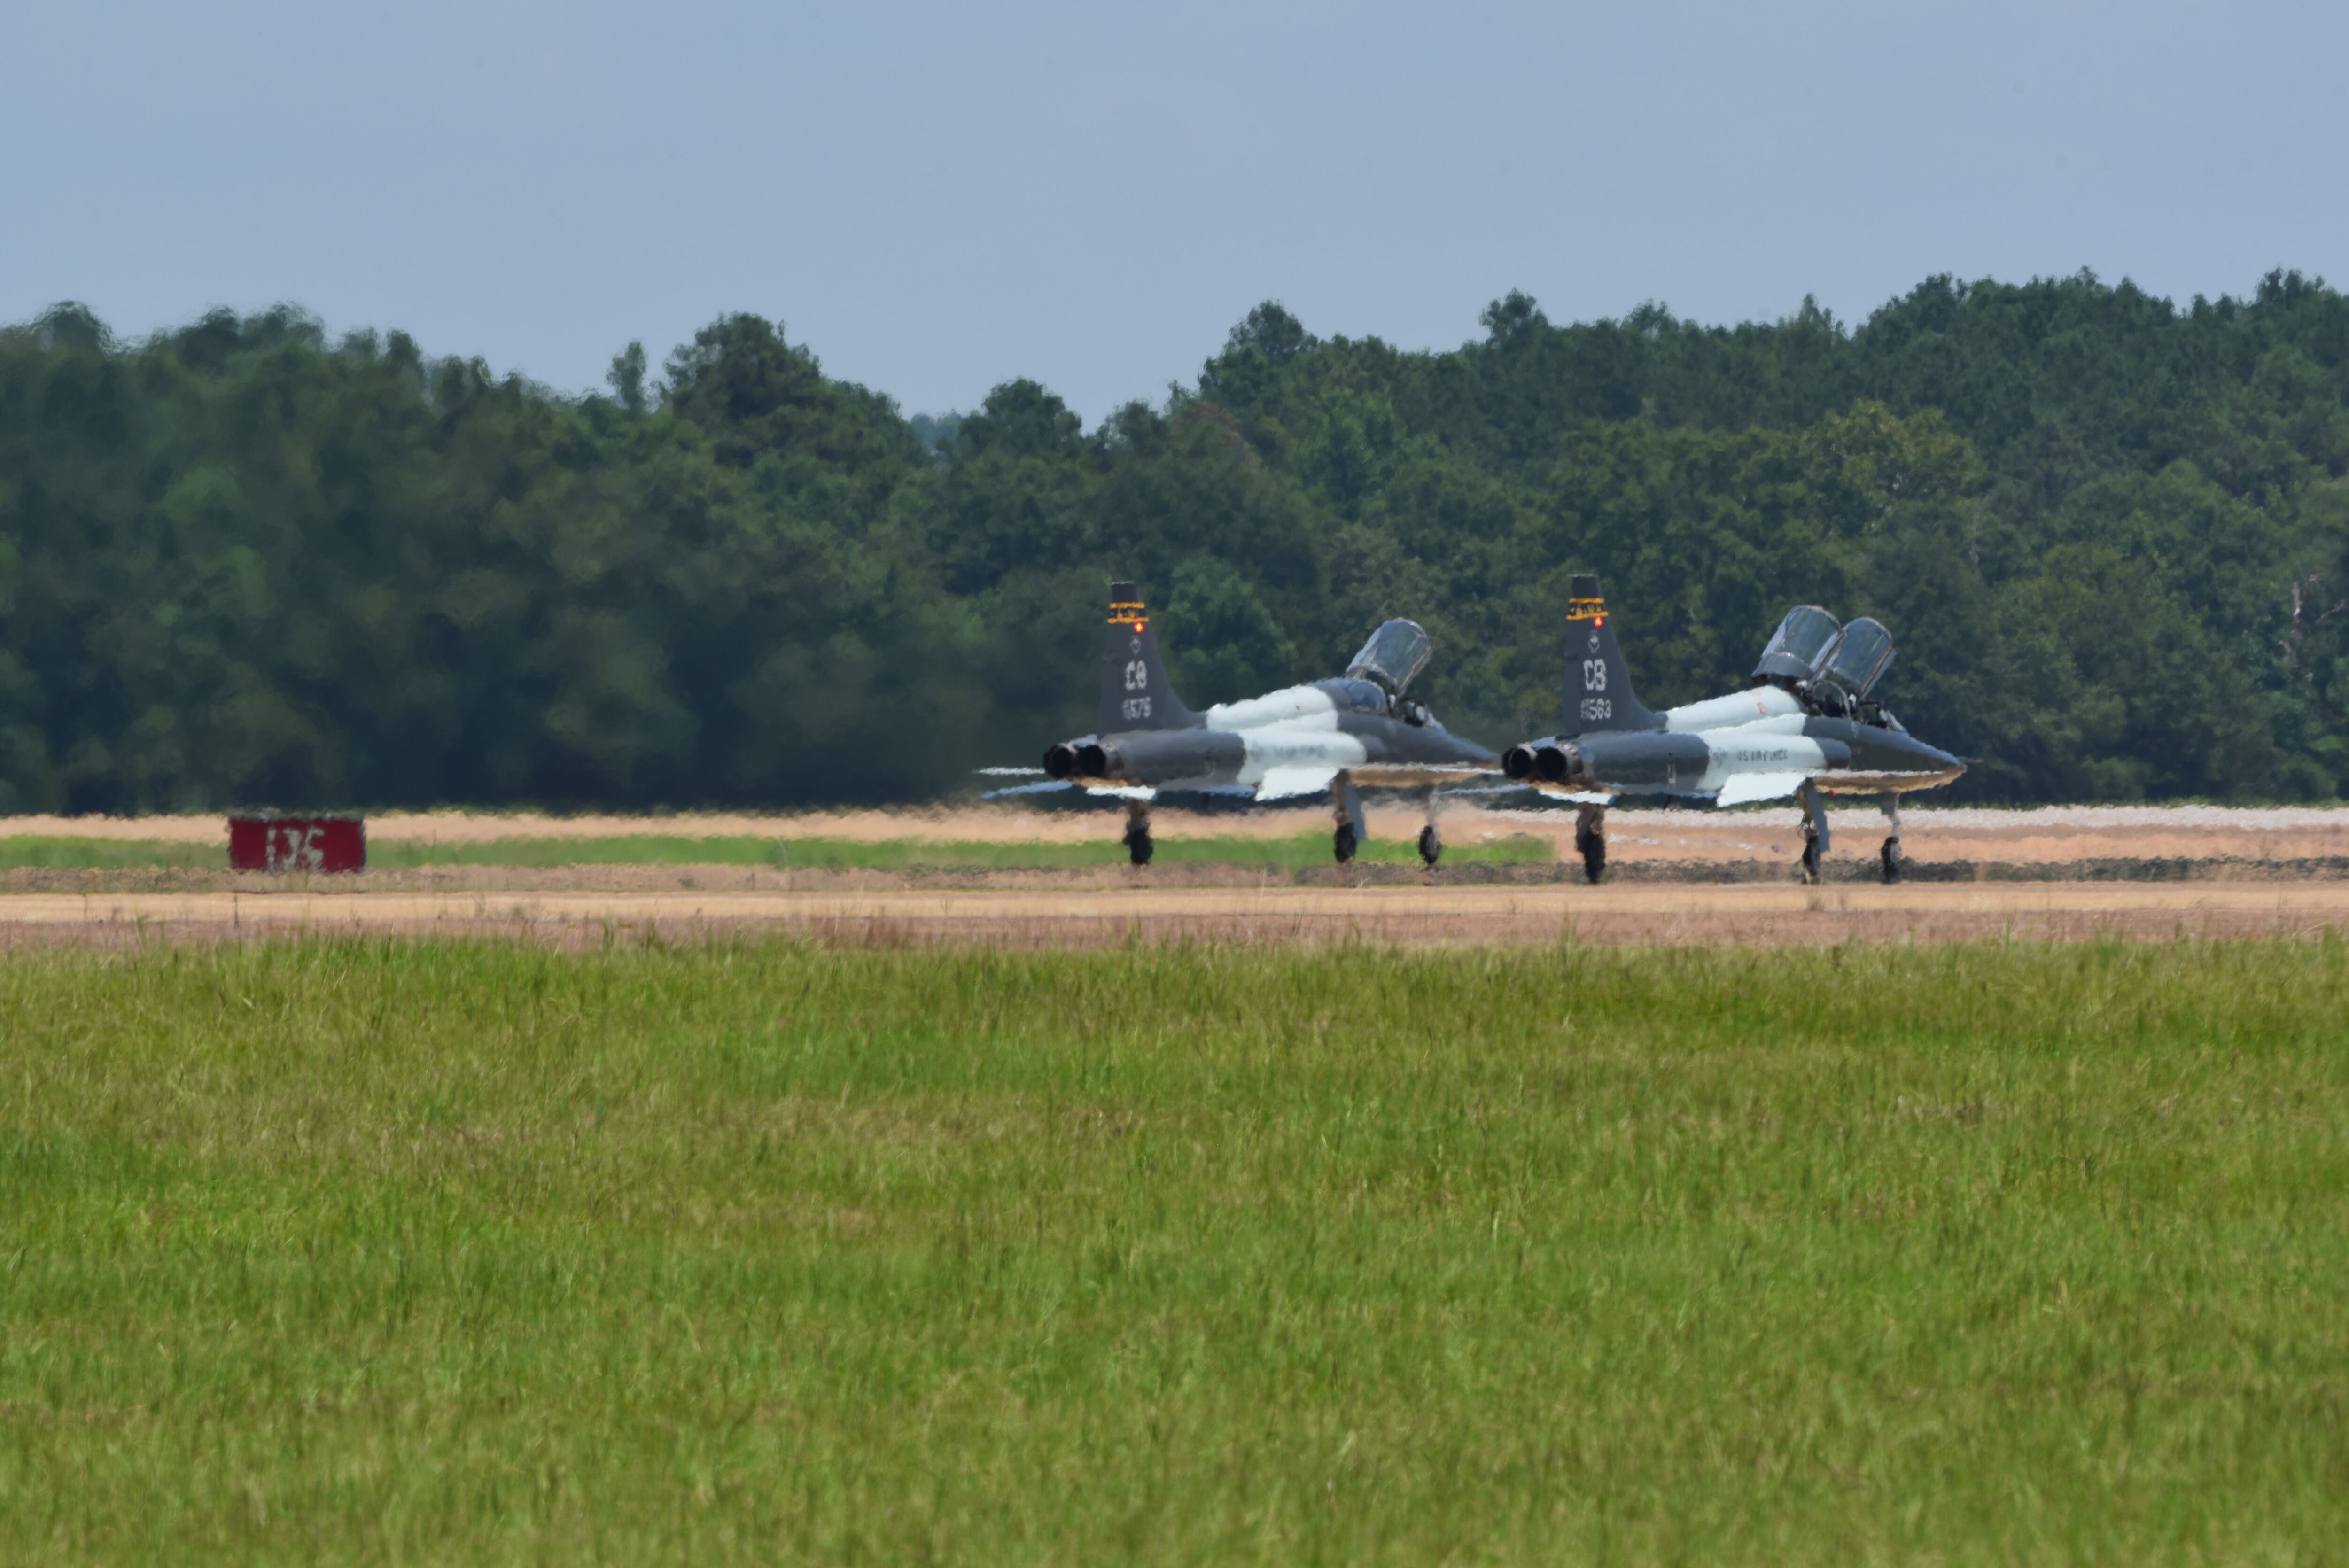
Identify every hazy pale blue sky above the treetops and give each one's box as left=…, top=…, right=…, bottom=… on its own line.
left=0, top=0, right=2349, bottom=418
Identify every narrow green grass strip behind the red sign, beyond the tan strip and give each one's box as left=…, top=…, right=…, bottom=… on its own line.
left=0, top=817, right=1555, bottom=871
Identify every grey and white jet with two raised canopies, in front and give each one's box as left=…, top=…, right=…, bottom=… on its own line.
left=1501, top=577, right=1966, bottom=883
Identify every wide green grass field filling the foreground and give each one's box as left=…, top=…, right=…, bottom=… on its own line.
left=0, top=944, right=2349, bottom=1563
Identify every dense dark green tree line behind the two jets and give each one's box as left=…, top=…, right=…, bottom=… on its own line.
left=0, top=275, right=2349, bottom=812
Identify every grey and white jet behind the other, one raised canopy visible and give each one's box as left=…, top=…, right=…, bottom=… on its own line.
left=998, top=582, right=1496, bottom=866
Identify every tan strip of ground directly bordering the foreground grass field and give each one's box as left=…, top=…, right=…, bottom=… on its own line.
left=0, top=883, right=2349, bottom=948
